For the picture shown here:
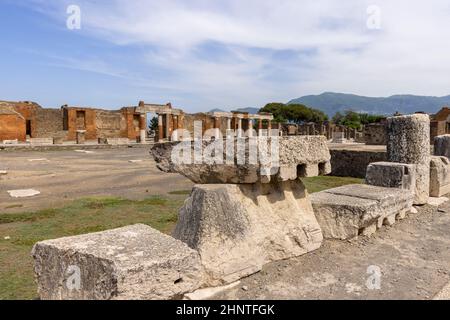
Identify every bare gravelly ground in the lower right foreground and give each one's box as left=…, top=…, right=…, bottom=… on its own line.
left=214, top=202, right=450, bottom=300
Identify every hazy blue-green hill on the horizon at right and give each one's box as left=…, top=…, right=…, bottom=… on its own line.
left=289, top=92, right=450, bottom=117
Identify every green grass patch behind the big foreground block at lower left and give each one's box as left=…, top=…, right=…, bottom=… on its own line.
left=0, top=196, right=184, bottom=299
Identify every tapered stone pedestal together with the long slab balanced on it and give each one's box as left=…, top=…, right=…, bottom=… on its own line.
left=152, top=136, right=331, bottom=286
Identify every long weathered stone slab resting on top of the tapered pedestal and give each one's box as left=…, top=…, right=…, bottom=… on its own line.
left=152, top=136, right=331, bottom=184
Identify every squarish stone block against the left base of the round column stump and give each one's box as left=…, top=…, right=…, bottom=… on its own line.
left=366, top=162, right=416, bottom=193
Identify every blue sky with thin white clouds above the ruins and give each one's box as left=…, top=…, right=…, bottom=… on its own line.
left=0, top=0, right=450, bottom=112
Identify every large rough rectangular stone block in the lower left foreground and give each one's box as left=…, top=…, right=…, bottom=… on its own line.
left=32, top=225, right=203, bottom=300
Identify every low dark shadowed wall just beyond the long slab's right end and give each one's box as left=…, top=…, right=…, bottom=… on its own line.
left=330, top=150, right=387, bottom=178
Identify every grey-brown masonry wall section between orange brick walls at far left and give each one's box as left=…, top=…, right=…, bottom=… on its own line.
left=31, top=109, right=63, bottom=138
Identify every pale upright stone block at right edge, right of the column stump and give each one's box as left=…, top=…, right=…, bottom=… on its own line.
left=430, top=156, right=450, bottom=198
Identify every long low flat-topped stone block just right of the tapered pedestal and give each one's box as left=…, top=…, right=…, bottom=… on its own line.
left=311, top=185, right=414, bottom=240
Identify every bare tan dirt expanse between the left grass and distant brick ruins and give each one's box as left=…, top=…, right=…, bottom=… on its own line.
left=0, top=148, right=192, bottom=213
